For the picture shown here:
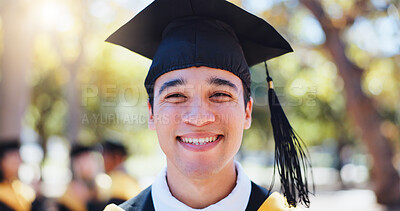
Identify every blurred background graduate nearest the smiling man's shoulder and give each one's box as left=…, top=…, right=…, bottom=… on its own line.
left=102, top=140, right=141, bottom=204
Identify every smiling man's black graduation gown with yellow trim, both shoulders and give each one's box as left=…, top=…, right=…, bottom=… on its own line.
left=104, top=182, right=298, bottom=211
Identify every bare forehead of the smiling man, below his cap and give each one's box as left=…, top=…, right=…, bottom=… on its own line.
left=154, top=66, right=242, bottom=90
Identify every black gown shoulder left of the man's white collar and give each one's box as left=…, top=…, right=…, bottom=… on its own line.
left=119, top=185, right=154, bottom=211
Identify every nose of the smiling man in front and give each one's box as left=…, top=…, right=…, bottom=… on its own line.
left=182, top=100, right=215, bottom=126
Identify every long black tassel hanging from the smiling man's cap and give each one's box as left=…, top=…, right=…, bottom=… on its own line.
left=264, top=62, right=314, bottom=207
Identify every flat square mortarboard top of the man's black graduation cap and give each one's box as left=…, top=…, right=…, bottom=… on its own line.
left=107, top=0, right=293, bottom=66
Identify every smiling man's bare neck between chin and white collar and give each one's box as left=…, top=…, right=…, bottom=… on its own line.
left=167, top=160, right=237, bottom=209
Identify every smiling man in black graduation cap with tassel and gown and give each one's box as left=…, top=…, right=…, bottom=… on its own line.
left=106, top=0, right=309, bottom=211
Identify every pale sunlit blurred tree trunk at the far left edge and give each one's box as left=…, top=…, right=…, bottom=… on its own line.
left=0, top=0, right=33, bottom=138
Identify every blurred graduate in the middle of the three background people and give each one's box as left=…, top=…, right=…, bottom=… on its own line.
left=57, top=144, right=103, bottom=211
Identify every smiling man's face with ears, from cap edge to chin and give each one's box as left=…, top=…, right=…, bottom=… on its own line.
left=149, top=67, right=252, bottom=178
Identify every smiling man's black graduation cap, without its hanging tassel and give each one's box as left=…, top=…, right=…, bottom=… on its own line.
left=106, top=0, right=293, bottom=91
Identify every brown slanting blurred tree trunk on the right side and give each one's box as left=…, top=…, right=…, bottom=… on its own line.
left=300, top=0, right=400, bottom=206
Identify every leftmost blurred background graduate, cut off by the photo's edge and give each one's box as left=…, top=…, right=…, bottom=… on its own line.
left=0, top=139, right=41, bottom=211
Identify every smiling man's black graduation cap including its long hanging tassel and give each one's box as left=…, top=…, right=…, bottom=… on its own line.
left=106, top=0, right=309, bottom=206
